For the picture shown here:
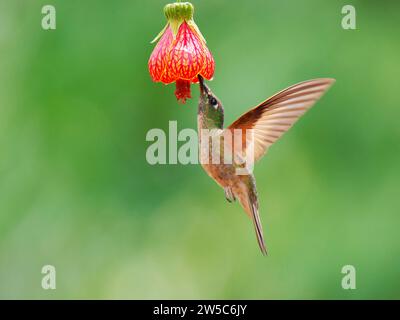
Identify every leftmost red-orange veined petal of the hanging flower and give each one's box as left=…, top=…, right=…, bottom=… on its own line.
left=148, top=26, right=174, bottom=83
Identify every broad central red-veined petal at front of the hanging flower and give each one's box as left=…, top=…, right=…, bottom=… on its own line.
left=167, top=22, right=206, bottom=80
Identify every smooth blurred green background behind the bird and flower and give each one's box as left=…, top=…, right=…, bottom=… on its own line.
left=0, top=0, right=400, bottom=299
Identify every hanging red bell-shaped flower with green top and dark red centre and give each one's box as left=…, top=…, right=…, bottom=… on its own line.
left=148, top=2, right=215, bottom=103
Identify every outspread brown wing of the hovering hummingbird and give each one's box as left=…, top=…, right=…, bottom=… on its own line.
left=228, top=78, right=335, bottom=162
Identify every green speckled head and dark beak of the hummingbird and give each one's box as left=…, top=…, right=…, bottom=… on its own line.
left=199, top=76, right=224, bottom=128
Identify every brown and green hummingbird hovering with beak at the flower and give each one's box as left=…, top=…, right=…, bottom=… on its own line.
left=197, top=76, right=335, bottom=255
